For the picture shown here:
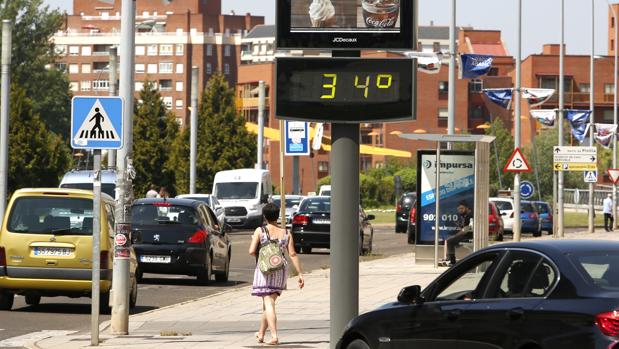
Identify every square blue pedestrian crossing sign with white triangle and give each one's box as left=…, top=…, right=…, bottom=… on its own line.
left=71, top=96, right=124, bottom=150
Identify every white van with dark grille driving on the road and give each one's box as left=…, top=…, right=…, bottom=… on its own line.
left=213, top=169, right=273, bottom=228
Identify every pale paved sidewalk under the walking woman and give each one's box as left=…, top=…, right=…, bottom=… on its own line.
left=29, top=254, right=444, bottom=349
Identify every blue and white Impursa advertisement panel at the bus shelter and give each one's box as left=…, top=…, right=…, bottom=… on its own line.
left=417, top=150, right=475, bottom=245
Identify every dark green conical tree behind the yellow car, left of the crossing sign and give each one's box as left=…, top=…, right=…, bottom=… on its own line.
left=8, top=84, right=71, bottom=193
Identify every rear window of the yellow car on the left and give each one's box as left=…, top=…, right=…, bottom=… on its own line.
left=8, top=197, right=93, bottom=235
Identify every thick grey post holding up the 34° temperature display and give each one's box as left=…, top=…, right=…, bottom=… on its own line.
left=330, top=124, right=361, bottom=349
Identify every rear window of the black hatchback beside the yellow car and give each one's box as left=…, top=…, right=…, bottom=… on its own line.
left=131, top=204, right=198, bottom=225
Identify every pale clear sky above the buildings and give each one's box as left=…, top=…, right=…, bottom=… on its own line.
left=44, top=0, right=616, bottom=57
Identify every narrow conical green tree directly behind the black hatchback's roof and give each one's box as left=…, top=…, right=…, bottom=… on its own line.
left=133, top=81, right=178, bottom=197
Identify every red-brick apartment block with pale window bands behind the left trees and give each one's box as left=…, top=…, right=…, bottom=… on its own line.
left=53, top=0, right=264, bottom=125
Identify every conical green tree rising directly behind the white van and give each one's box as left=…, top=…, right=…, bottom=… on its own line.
left=196, top=72, right=257, bottom=192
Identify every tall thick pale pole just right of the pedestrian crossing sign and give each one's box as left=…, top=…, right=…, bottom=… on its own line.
left=111, top=0, right=136, bottom=335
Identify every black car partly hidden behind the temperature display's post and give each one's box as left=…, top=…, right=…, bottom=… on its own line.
left=292, top=196, right=374, bottom=254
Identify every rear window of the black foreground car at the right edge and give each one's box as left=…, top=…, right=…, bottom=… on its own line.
left=570, top=251, right=619, bottom=291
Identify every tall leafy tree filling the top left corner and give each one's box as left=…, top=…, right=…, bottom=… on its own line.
left=0, top=0, right=71, bottom=137
